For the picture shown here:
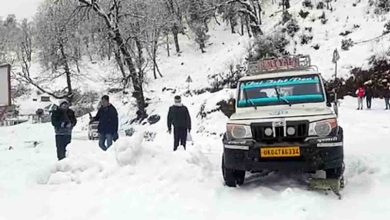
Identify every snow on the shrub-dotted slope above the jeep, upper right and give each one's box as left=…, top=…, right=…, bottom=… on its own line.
left=262, top=0, right=390, bottom=79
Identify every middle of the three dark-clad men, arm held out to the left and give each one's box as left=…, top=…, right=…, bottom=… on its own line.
left=91, top=95, right=118, bottom=151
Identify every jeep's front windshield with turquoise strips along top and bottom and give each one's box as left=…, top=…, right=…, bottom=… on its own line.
left=238, top=75, right=325, bottom=107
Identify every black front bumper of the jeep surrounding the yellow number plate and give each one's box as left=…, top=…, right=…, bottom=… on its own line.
left=223, top=135, right=344, bottom=172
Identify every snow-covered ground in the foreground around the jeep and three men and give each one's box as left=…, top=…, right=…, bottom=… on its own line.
left=0, top=98, right=390, bottom=220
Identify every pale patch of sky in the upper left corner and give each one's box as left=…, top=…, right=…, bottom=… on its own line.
left=0, top=0, right=43, bottom=19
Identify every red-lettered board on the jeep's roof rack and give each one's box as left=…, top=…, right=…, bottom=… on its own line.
left=249, top=56, right=311, bottom=74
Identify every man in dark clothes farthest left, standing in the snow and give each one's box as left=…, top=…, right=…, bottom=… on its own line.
left=51, top=100, right=77, bottom=160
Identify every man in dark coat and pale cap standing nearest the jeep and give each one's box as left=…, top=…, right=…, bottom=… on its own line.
left=167, top=96, right=191, bottom=151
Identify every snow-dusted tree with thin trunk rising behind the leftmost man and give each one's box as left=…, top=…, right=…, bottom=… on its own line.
left=24, top=0, right=86, bottom=101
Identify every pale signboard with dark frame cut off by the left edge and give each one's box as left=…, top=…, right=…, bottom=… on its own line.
left=0, top=64, right=11, bottom=106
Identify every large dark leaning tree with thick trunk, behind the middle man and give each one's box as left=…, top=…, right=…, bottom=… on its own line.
left=79, top=0, right=147, bottom=117
